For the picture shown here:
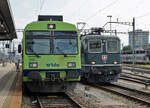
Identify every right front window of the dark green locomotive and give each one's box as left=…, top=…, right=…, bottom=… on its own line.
left=107, top=40, right=118, bottom=53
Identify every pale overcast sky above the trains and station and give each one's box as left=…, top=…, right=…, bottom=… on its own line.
left=10, top=0, right=150, bottom=45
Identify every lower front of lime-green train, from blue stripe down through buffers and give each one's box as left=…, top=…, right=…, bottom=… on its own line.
left=23, top=66, right=81, bottom=92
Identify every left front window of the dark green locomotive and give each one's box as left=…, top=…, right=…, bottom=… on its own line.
left=89, top=40, right=102, bottom=53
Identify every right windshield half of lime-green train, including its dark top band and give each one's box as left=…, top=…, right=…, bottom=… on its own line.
left=53, top=31, right=78, bottom=54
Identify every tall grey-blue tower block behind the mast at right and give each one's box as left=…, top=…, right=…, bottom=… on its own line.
left=129, top=29, right=149, bottom=50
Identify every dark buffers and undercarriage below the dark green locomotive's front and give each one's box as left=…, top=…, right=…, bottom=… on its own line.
left=82, top=66, right=121, bottom=83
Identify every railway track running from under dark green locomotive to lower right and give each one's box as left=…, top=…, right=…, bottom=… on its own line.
left=94, top=84, right=150, bottom=107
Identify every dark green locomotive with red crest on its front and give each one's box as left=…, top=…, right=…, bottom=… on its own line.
left=81, top=34, right=122, bottom=83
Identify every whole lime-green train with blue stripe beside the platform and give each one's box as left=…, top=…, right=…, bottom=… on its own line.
left=19, top=16, right=81, bottom=92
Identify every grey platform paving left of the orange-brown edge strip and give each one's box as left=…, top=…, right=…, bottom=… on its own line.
left=0, top=63, right=17, bottom=108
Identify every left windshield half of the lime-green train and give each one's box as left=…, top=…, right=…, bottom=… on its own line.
left=26, top=32, right=50, bottom=55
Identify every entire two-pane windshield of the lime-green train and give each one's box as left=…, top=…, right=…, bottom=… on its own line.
left=26, top=31, right=78, bottom=55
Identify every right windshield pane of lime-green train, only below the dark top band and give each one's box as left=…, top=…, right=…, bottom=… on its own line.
left=54, top=38, right=78, bottom=54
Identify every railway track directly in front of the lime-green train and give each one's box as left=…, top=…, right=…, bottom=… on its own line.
left=32, top=94, right=81, bottom=108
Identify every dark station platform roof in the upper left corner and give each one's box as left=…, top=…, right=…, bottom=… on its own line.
left=0, top=0, right=17, bottom=41
